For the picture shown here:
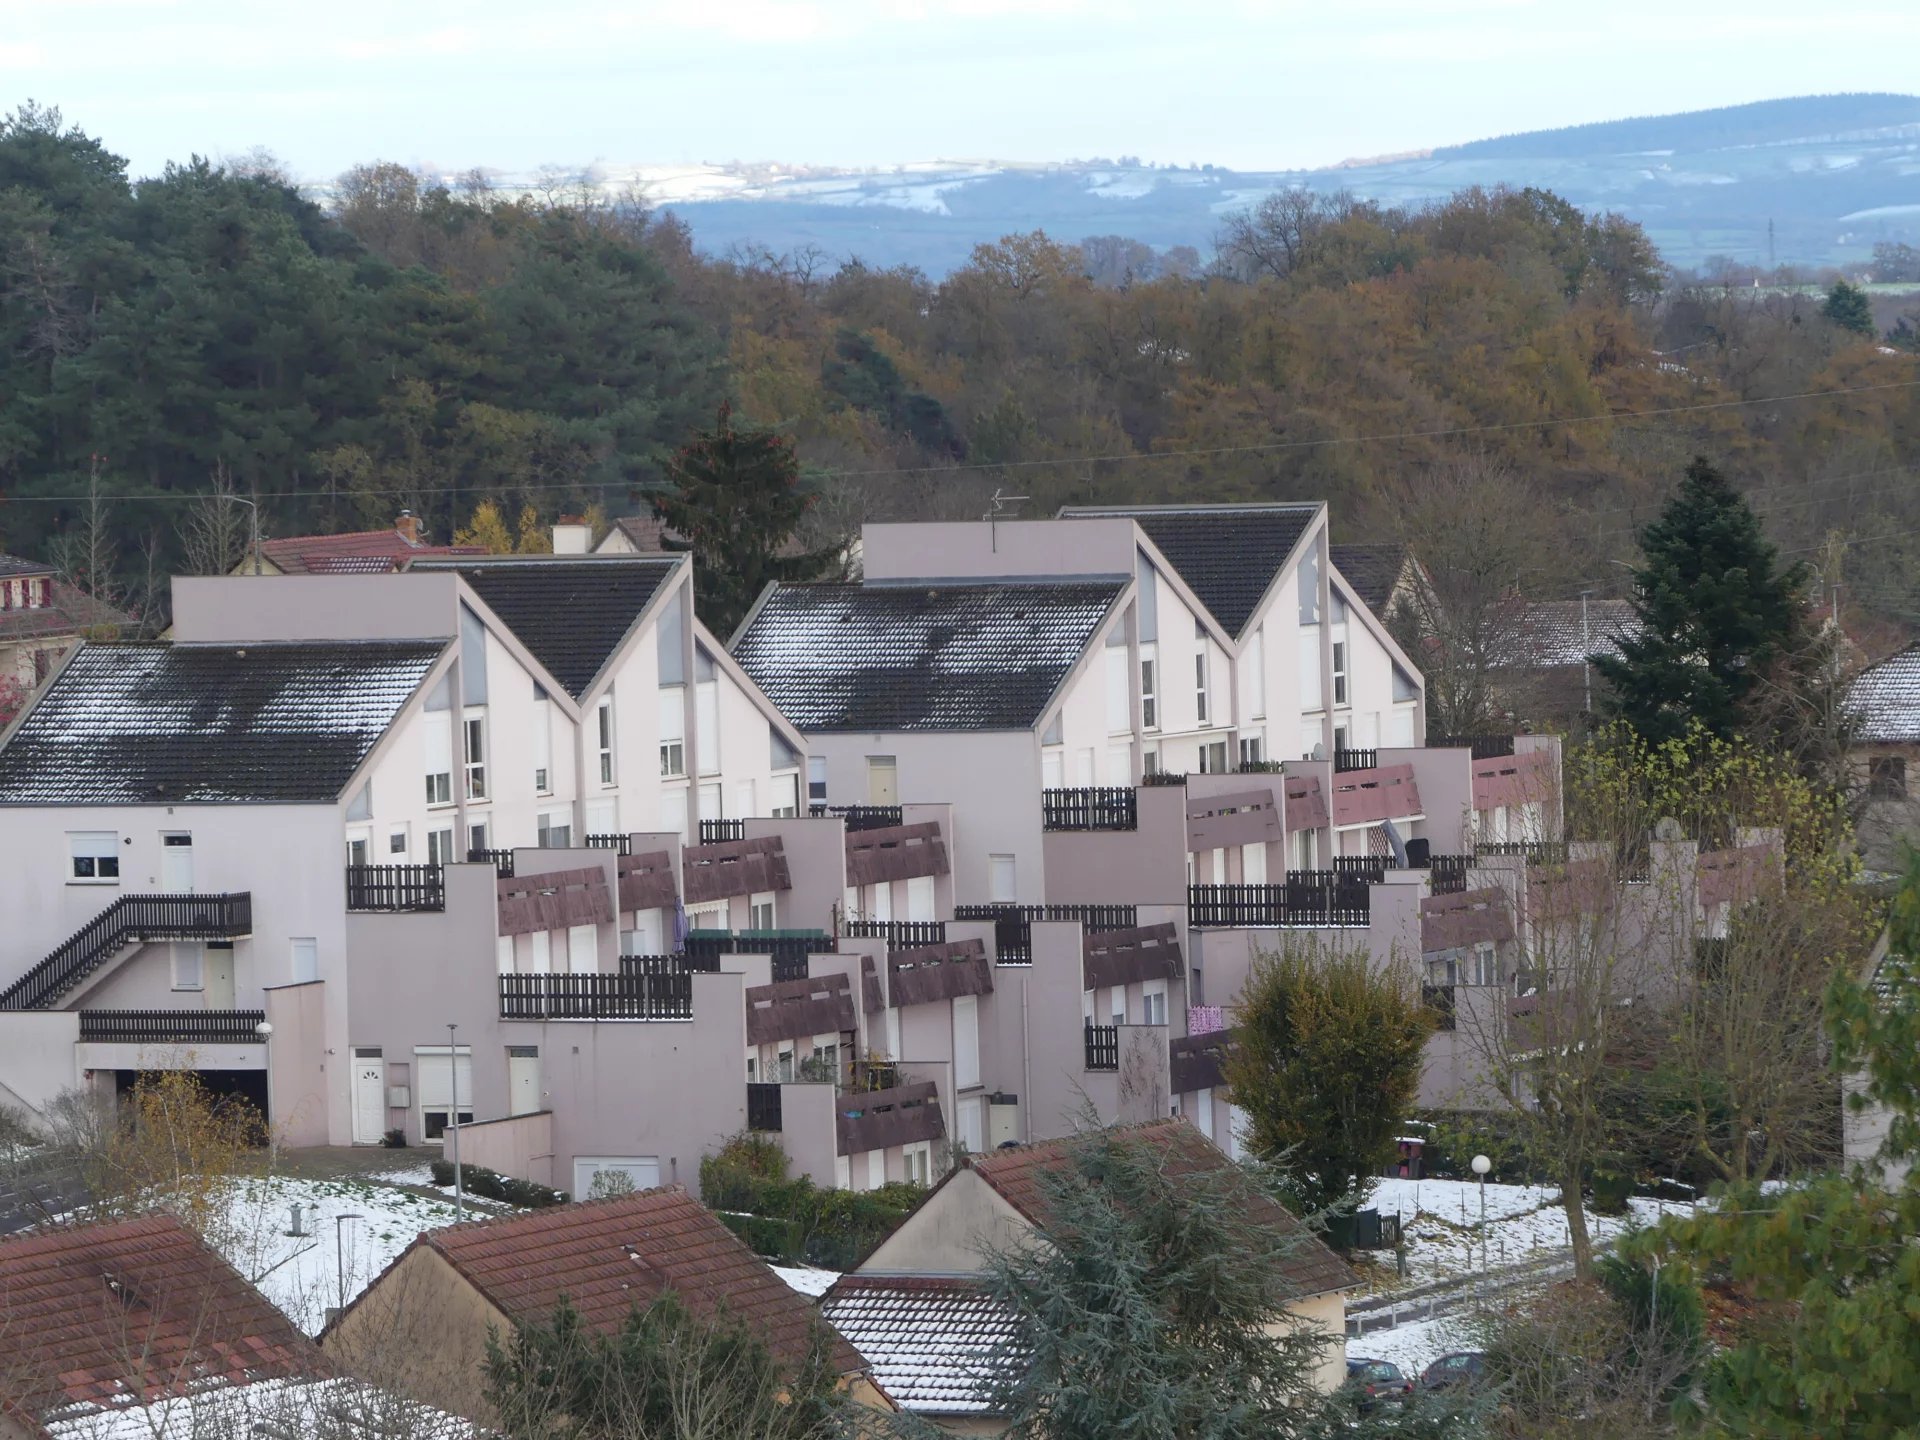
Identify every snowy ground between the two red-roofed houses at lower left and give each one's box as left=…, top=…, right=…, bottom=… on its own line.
left=209, top=1177, right=457, bottom=1334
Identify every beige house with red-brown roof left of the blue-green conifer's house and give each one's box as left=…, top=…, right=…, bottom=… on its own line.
left=321, top=1187, right=893, bottom=1421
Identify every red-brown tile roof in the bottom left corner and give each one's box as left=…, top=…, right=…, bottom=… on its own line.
left=0, top=1215, right=328, bottom=1415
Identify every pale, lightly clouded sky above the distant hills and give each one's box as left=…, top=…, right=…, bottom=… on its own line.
left=0, top=0, right=1920, bottom=180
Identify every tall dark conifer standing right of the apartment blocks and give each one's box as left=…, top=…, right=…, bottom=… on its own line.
left=1592, top=457, right=1807, bottom=743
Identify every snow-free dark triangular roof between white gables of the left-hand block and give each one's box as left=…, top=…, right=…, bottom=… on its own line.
left=409, top=555, right=685, bottom=701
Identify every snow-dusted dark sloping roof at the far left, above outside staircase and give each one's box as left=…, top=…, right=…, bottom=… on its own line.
left=0, top=639, right=447, bottom=804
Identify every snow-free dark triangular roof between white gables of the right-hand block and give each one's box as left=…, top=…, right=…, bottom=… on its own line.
left=1060, top=505, right=1319, bottom=637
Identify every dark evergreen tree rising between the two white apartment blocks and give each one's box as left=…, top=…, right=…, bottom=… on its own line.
left=653, top=405, right=833, bottom=641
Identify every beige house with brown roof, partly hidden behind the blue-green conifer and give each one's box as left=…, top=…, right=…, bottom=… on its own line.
left=822, top=1119, right=1357, bottom=1434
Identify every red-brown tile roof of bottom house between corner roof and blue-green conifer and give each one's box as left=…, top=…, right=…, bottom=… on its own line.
left=397, top=1187, right=866, bottom=1375
